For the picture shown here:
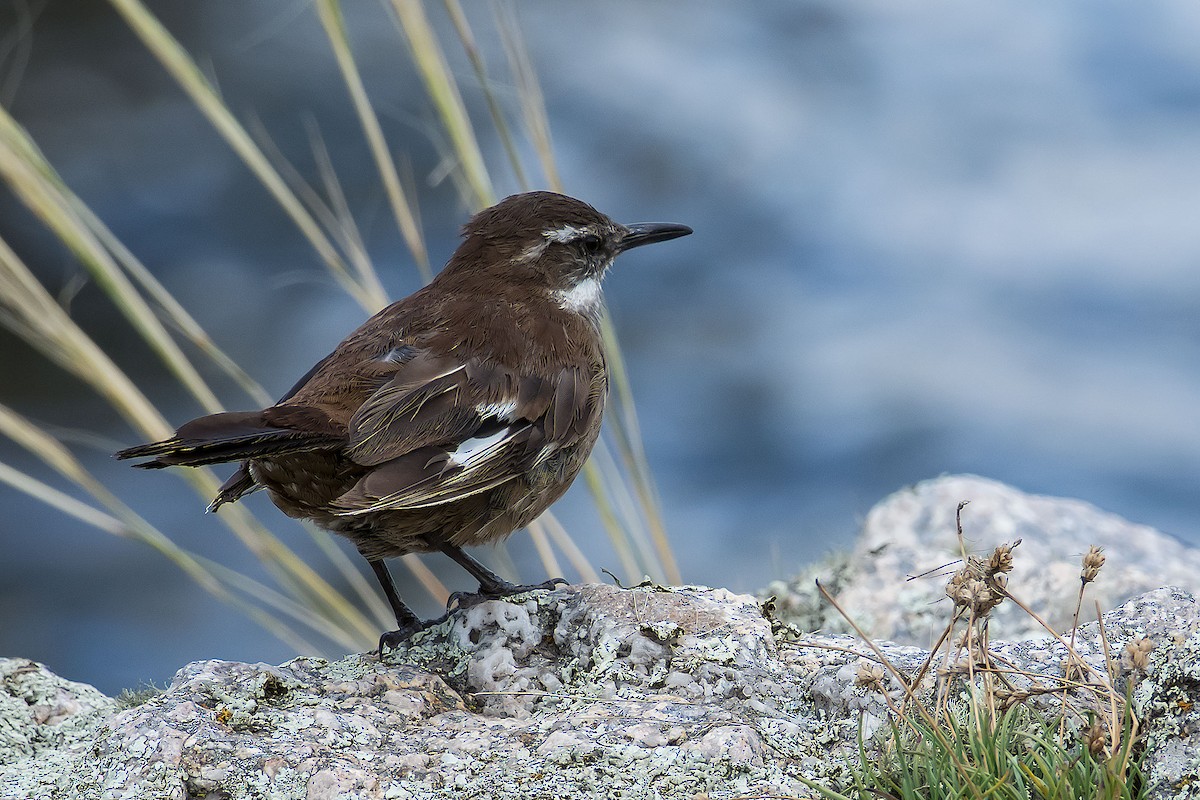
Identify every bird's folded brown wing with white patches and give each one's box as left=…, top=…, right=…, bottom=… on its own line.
left=335, top=354, right=602, bottom=515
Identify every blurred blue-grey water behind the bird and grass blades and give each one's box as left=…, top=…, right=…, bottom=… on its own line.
left=0, top=0, right=1200, bottom=692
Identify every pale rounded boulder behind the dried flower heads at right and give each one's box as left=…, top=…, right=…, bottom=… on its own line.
left=763, top=475, right=1200, bottom=646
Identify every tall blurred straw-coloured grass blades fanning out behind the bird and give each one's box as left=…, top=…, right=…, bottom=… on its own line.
left=0, top=0, right=679, bottom=676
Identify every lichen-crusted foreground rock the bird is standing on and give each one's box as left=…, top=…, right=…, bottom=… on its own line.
left=0, top=585, right=1200, bottom=800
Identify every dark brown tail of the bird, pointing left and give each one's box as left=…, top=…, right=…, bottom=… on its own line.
left=116, top=407, right=346, bottom=469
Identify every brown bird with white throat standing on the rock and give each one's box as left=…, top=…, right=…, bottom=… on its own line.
left=116, top=192, right=691, bottom=648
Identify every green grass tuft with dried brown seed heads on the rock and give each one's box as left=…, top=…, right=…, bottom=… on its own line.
left=814, top=503, right=1153, bottom=800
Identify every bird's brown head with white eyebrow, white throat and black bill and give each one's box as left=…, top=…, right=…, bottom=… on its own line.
left=443, top=192, right=691, bottom=315
